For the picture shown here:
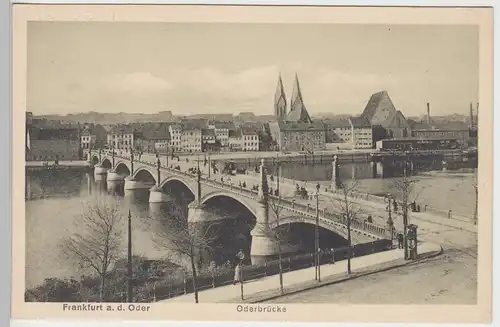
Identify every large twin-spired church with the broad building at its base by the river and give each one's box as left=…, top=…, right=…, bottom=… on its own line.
left=269, top=74, right=326, bottom=152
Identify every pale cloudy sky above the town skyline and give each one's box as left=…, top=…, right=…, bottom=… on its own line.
left=27, top=22, right=479, bottom=116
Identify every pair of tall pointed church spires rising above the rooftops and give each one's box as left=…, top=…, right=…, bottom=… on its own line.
left=274, top=74, right=312, bottom=123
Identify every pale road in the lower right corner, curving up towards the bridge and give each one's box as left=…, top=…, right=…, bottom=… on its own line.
left=264, top=204, right=478, bottom=304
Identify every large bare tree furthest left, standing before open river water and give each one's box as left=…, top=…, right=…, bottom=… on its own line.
left=62, top=198, right=123, bottom=301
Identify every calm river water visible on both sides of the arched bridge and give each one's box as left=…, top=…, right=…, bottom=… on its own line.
left=26, top=163, right=476, bottom=287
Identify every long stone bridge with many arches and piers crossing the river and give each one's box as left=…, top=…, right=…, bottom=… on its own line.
left=88, top=151, right=393, bottom=262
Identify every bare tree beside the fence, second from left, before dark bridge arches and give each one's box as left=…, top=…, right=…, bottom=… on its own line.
left=147, top=202, right=218, bottom=303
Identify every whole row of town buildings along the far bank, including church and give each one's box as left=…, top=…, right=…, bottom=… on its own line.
left=26, top=75, right=477, bottom=160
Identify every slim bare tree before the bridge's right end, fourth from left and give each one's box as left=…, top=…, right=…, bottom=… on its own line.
left=331, top=180, right=363, bottom=274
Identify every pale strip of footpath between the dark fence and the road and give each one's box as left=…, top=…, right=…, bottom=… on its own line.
left=161, top=243, right=442, bottom=303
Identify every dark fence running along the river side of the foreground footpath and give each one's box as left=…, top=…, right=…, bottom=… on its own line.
left=142, top=239, right=392, bottom=302
